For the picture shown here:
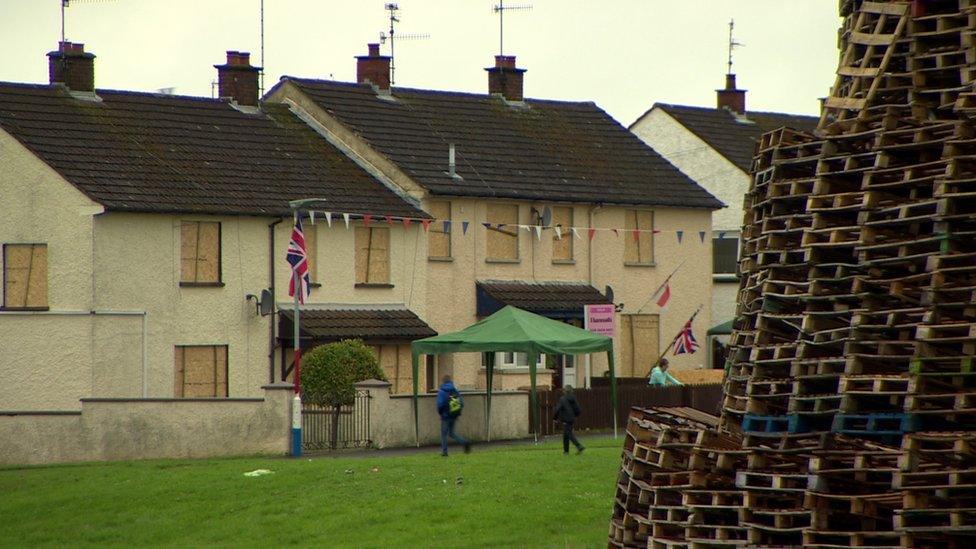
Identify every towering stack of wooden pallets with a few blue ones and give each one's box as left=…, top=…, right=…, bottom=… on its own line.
left=609, top=0, right=976, bottom=548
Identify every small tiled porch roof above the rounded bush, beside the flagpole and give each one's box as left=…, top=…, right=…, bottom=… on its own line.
left=279, top=307, right=437, bottom=343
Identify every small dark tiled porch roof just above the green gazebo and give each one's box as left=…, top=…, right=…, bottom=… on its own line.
left=476, top=280, right=611, bottom=318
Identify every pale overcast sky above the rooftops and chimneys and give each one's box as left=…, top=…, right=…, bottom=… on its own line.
left=0, top=0, right=840, bottom=125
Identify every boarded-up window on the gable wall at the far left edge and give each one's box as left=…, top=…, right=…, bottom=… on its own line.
left=3, top=244, right=48, bottom=309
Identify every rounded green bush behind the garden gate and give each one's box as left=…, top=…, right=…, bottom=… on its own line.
left=301, top=339, right=386, bottom=406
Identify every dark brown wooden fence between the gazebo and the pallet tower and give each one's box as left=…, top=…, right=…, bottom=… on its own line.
left=529, top=380, right=722, bottom=435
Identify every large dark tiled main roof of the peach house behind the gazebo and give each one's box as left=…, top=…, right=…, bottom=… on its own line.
left=269, top=77, right=723, bottom=208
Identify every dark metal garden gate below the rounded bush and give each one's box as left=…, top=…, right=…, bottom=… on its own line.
left=302, top=390, right=372, bottom=453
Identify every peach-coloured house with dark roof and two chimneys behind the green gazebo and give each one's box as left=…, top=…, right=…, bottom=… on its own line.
left=265, top=44, right=723, bottom=389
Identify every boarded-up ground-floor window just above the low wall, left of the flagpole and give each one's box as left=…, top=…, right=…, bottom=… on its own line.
left=173, top=345, right=227, bottom=398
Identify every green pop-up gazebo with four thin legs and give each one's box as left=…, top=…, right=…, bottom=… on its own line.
left=410, top=305, right=617, bottom=446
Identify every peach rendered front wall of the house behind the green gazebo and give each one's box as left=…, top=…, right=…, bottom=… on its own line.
left=427, top=197, right=712, bottom=389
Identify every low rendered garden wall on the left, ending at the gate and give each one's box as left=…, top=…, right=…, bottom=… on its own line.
left=0, top=383, right=293, bottom=465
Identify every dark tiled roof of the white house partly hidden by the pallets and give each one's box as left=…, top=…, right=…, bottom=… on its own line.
left=652, top=103, right=820, bottom=172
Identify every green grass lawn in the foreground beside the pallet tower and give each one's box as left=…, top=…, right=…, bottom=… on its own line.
left=0, top=438, right=622, bottom=547
